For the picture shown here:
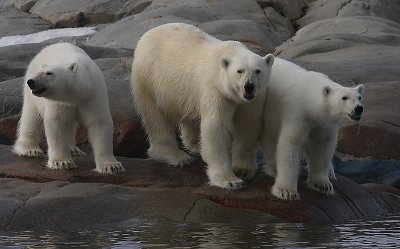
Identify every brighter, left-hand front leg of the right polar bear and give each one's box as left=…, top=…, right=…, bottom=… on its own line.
left=272, top=122, right=306, bottom=200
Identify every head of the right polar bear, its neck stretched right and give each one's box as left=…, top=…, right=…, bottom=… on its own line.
left=323, top=84, right=365, bottom=121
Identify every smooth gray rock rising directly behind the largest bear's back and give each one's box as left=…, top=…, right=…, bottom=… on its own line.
left=86, top=0, right=292, bottom=50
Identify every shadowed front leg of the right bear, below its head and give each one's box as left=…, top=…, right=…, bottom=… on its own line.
left=306, top=126, right=338, bottom=195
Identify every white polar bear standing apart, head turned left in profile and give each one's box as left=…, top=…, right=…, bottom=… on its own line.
left=14, top=43, right=124, bottom=173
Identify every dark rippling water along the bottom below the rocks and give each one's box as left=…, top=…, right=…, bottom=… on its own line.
left=0, top=215, right=400, bottom=248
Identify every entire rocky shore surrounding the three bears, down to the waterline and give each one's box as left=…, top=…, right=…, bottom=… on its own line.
left=0, top=0, right=400, bottom=229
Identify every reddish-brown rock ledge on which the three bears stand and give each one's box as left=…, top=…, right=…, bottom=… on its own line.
left=0, top=145, right=400, bottom=222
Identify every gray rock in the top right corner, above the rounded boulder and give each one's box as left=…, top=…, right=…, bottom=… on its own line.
left=297, top=0, right=400, bottom=27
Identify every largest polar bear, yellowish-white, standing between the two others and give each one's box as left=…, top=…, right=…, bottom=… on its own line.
left=132, top=23, right=274, bottom=189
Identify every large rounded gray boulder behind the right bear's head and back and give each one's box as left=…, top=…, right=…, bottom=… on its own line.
left=277, top=17, right=400, bottom=85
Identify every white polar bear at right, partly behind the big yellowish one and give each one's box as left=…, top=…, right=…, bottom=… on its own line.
left=260, top=58, right=364, bottom=200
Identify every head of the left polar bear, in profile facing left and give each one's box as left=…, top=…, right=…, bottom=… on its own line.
left=26, top=62, right=78, bottom=100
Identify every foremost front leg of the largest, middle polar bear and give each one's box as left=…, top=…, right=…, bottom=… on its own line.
left=200, top=100, right=243, bottom=189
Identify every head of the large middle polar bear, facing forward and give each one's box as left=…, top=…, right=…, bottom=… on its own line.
left=221, top=41, right=275, bottom=102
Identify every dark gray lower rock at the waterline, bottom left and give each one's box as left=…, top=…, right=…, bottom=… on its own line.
left=0, top=178, right=278, bottom=229
